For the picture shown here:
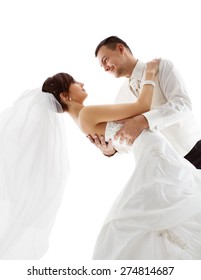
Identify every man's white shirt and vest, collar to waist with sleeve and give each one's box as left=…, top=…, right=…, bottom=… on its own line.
left=116, top=59, right=201, bottom=156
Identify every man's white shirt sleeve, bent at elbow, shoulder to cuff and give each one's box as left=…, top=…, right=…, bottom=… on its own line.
left=143, top=60, right=192, bottom=131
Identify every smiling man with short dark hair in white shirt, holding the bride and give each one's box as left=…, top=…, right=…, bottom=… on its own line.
left=88, top=36, right=201, bottom=169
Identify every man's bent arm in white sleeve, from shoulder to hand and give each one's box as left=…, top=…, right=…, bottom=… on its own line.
left=115, top=60, right=191, bottom=144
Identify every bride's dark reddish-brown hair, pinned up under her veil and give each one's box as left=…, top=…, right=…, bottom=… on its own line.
left=42, top=73, right=75, bottom=111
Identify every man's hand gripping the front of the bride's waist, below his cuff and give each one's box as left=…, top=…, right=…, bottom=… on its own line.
left=114, top=115, right=149, bottom=145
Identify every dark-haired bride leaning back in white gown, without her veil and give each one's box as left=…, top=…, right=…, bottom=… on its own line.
left=42, top=60, right=201, bottom=260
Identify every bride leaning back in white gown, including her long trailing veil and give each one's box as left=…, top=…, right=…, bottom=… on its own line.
left=0, top=60, right=201, bottom=260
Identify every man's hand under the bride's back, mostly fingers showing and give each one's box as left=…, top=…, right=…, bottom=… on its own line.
left=87, top=134, right=116, bottom=157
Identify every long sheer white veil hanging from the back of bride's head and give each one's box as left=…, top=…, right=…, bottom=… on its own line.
left=0, top=89, right=69, bottom=259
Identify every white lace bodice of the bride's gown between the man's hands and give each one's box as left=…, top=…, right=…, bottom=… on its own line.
left=105, top=122, right=132, bottom=153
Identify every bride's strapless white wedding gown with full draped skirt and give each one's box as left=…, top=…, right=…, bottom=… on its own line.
left=93, top=122, right=201, bottom=260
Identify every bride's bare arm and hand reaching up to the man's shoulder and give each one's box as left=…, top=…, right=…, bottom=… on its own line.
left=79, top=60, right=159, bottom=134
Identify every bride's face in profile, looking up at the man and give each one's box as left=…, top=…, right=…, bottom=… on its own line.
left=68, top=82, right=88, bottom=104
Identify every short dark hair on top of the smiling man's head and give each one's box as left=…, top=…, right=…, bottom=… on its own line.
left=95, top=36, right=132, bottom=57
